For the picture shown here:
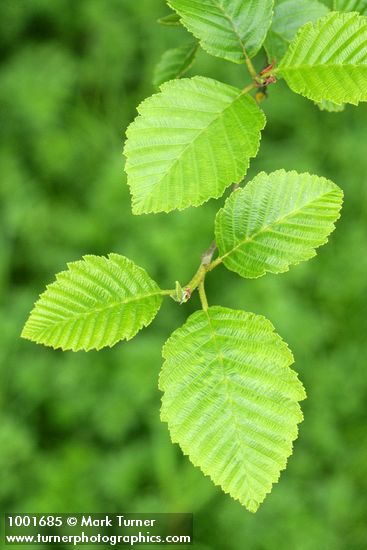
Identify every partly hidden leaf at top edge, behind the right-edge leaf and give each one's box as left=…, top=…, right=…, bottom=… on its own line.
left=265, top=0, right=329, bottom=62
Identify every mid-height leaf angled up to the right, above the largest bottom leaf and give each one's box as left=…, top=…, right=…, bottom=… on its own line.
left=215, top=170, right=343, bottom=279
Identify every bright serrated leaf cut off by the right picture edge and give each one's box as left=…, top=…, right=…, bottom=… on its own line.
left=278, top=12, right=367, bottom=105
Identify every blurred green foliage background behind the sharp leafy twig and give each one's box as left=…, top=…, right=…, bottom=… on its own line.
left=0, top=0, right=367, bottom=550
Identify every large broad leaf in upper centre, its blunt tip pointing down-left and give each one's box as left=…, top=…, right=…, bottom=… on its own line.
left=124, top=77, right=265, bottom=214
